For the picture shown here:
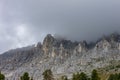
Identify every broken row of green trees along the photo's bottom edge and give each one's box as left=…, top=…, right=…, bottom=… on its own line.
left=0, top=69, right=120, bottom=80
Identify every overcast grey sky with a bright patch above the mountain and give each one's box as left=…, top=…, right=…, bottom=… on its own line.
left=0, top=0, right=120, bottom=53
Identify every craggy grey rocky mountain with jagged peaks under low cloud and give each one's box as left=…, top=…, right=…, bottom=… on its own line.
left=0, top=33, right=120, bottom=80
